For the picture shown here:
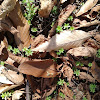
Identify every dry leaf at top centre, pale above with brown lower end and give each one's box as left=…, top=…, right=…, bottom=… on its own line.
left=39, top=0, right=57, bottom=17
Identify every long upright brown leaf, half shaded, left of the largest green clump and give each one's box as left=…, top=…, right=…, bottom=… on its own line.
left=9, top=2, right=30, bottom=50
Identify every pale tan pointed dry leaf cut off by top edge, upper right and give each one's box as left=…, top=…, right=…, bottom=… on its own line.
left=76, top=0, right=98, bottom=17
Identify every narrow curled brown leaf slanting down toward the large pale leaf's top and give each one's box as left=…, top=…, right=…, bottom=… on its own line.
left=48, top=4, right=76, bottom=37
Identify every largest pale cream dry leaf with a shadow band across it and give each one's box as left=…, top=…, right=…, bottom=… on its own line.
left=32, top=30, right=91, bottom=52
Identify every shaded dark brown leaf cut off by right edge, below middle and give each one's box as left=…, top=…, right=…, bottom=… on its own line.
left=91, top=61, right=100, bottom=82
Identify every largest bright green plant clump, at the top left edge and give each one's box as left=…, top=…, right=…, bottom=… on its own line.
left=22, top=0, right=38, bottom=24
